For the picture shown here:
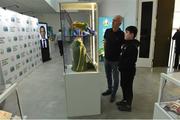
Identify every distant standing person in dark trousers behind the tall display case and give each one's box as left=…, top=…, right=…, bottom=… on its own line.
left=56, top=29, right=63, bottom=56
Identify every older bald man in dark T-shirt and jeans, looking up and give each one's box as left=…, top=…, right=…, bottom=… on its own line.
left=102, top=15, right=124, bottom=102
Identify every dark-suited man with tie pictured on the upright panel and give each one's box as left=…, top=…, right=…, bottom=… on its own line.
left=40, top=26, right=51, bottom=62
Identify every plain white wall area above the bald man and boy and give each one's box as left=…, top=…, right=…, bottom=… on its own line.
left=98, top=0, right=137, bottom=27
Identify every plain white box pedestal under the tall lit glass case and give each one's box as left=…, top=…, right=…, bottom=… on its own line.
left=64, top=66, right=101, bottom=117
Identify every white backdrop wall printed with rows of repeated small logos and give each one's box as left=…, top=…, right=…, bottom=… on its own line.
left=0, top=8, right=41, bottom=88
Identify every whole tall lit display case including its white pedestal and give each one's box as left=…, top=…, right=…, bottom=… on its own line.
left=60, top=2, right=101, bottom=117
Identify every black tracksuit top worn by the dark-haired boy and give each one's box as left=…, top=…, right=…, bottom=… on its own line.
left=119, top=39, right=139, bottom=71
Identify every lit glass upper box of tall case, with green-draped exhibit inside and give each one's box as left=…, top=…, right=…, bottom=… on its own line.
left=60, top=3, right=98, bottom=73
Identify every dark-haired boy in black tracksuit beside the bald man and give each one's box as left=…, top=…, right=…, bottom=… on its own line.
left=116, top=26, right=139, bottom=111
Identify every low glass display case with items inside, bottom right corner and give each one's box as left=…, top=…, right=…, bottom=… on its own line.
left=154, top=72, right=180, bottom=119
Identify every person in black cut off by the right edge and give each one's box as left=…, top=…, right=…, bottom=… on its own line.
left=172, top=28, right=180, bottom=69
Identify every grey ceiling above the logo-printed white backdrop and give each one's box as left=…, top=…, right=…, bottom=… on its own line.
left=0, top=0, right=55, bottom=16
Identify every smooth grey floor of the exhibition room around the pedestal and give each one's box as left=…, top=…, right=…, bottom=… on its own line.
left=13, top=49, right=169, bottom=119
